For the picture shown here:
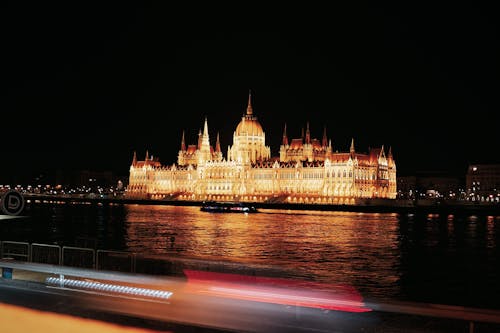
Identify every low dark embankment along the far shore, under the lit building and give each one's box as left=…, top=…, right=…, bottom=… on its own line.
left=17, top=194, right=500, bottom=216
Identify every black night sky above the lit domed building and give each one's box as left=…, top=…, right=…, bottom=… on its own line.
left=0, top=1, right=500, bottom=184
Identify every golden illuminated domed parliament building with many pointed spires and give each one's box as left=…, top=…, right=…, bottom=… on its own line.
left=127, top=92, right=397, bottom=204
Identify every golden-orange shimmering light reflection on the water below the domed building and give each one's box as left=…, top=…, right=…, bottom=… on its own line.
left=126, top=206, right=399, bottom=296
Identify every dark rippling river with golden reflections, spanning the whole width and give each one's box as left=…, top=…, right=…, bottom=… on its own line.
left=0, top=203, right=500, bottom=309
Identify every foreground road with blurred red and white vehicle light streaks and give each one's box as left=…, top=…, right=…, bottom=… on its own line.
left=0, top=261, right=500, bottom=333
